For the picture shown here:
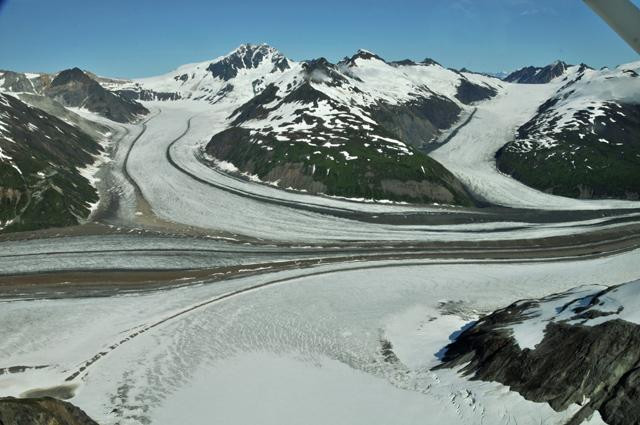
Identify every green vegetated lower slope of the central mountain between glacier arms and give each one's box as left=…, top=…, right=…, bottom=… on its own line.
left=207, top=122, right=472, bottom=205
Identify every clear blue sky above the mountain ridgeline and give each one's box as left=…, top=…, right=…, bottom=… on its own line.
left=0, top=0, right=638, bottom=77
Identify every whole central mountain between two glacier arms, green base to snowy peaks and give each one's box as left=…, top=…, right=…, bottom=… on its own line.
left=117, top=45, right=502, bottom=204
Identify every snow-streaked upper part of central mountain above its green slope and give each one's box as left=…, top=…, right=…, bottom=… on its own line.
left=219, top=46, right=500, bottom=146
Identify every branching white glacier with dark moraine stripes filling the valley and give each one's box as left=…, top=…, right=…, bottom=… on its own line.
left=0, top=85, right=640, bottom=425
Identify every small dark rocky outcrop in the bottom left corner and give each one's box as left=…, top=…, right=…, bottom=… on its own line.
left=0, top=397, right=98, bottom=425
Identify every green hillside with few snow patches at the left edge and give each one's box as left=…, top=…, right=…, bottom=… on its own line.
left=0, top=94, right=102, bottom=232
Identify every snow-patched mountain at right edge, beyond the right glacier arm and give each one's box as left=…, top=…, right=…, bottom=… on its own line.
left=497, top=62, right=640, bottom=199
